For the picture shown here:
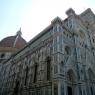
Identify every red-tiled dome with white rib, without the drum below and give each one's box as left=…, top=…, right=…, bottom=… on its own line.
left=0, top=29, right=26, bottom=49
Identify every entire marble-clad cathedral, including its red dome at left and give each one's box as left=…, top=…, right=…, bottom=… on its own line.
left=0, top=8, right=95, bottom=95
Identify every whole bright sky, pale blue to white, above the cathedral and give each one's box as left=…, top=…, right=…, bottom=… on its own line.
left=0, top=0, right=95, bottom=41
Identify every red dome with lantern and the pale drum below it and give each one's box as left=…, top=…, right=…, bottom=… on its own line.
left=0, top=29, right=27, bottom=62
